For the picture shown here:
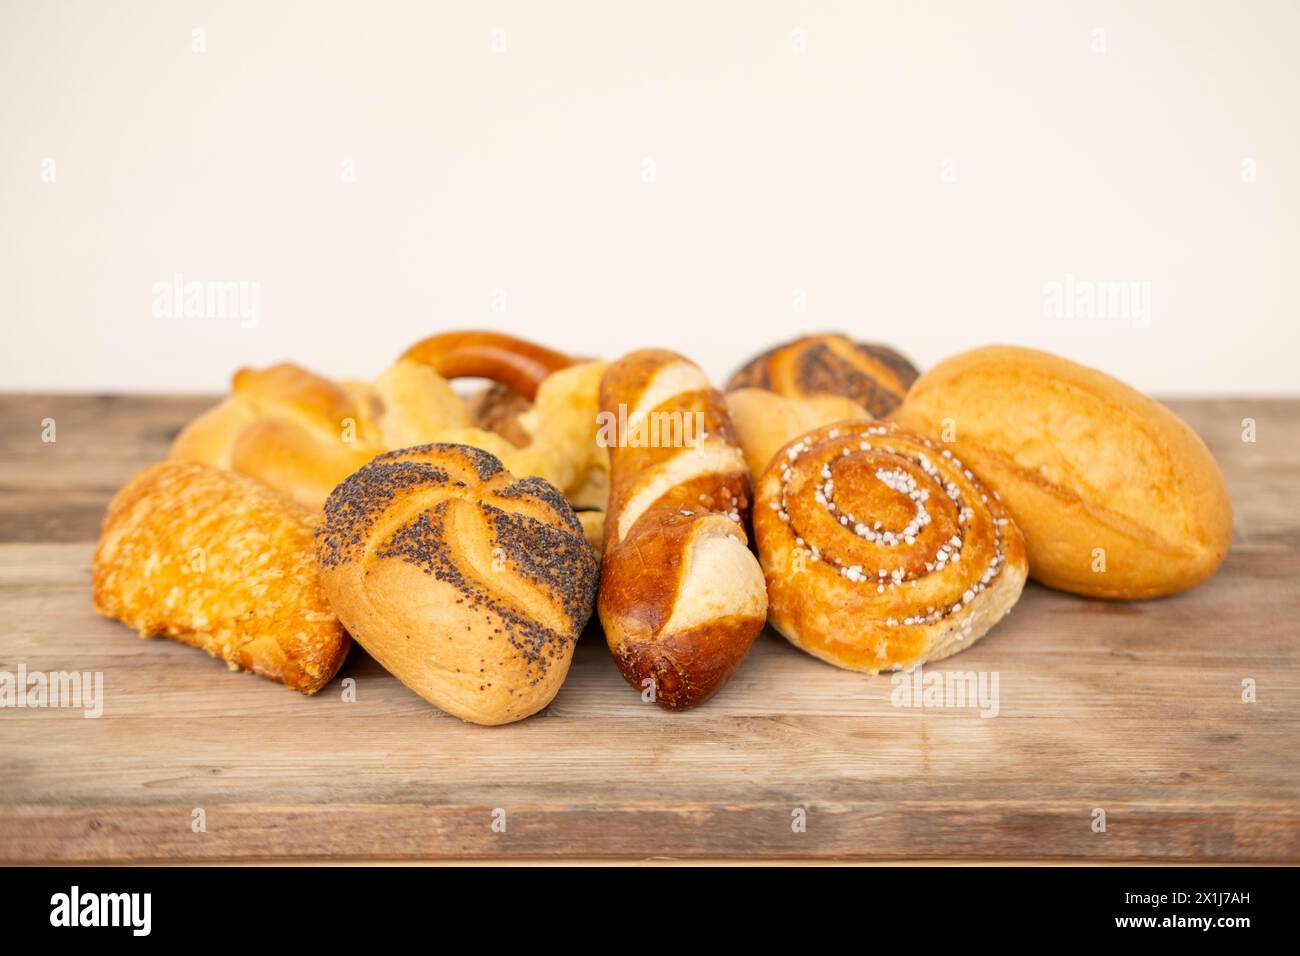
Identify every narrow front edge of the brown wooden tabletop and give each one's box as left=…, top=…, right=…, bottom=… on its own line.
left=0, top=801, right=1300, bottom=864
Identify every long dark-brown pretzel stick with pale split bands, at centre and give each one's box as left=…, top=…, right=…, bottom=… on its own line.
left=599, top=350, right=767, bottom=710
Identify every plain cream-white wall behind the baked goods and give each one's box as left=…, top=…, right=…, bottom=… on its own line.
left=0, top=0, right=1300, bottom=394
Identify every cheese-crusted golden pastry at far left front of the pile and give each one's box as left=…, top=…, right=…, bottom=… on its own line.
left=91, top=462, right=351, bottom=693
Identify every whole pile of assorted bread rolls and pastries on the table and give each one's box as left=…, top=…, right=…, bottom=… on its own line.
left=94, top=332, right=1232, bottom=724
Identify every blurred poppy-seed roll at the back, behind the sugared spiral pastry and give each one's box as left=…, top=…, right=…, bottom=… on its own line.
left=727, top=336, right=917, bottom=419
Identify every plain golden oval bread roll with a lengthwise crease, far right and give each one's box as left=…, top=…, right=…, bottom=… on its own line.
left=896, top=346, right=1232, bottom=598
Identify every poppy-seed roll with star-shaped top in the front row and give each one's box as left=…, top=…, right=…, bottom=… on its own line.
left=316, top=445, right=597, bottom=724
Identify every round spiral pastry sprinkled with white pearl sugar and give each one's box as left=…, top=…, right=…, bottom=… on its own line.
left=754, top=421, right=1028, bottom=674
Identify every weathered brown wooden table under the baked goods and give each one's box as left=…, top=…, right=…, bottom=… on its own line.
left=0, top=395, right=1300, bottom=862
